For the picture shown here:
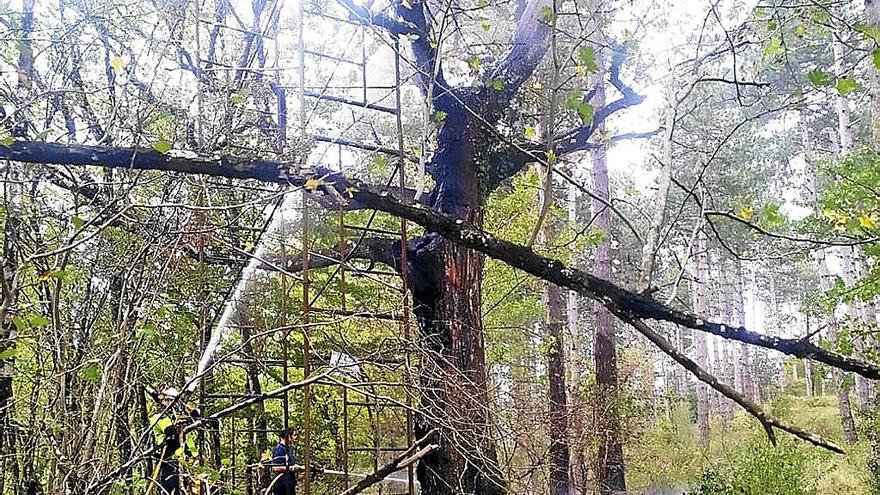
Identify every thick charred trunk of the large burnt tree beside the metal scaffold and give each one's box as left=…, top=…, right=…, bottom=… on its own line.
left=407, top=106, right=506, bottom=495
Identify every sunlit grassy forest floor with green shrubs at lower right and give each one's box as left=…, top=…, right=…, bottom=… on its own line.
left=627, top=388, right=871, bottom=495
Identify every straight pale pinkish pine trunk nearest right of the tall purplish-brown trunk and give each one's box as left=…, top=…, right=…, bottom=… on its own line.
left=692, top=230, right=709, bottom=449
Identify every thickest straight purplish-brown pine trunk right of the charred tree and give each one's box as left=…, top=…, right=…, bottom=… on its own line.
left=592, top=82, right=626, bottom=494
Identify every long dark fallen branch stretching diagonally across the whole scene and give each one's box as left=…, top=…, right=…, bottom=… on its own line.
left=6, top=141, right=880, bottom=380
